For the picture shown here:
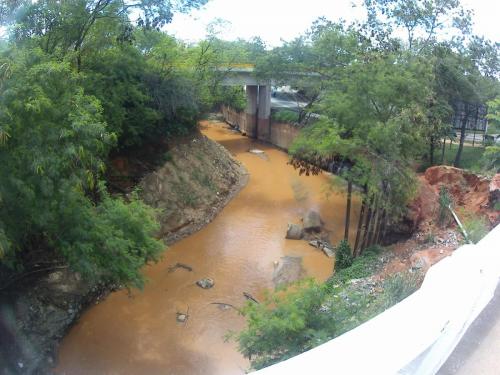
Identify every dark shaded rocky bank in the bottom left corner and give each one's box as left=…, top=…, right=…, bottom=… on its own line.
left=0, top=268, right=111, bottom=374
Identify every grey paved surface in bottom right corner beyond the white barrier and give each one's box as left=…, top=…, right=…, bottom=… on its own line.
left=438, top=284, right=500, bottom=375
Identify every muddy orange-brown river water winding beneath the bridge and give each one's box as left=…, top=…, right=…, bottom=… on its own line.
left=56, top=124, right=359, bottom=375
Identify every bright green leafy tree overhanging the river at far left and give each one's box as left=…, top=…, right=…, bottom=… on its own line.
left=0, top=50, right=163, bottom=286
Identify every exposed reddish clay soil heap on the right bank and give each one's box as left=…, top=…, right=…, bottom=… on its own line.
left=379, top=166, right=500, bottom=278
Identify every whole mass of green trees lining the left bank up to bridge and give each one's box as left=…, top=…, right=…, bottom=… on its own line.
left=0, top=0, right=263, bottom=287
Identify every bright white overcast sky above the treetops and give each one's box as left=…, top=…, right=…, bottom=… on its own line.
left=167, top=0, right=500, bottom=46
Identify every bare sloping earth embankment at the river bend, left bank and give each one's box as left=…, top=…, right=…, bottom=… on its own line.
left=139, top=134, right=247, bottom=243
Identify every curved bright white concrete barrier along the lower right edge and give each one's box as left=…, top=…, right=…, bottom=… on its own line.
left=254, top=225, right=500, bottom=375
